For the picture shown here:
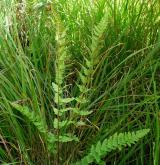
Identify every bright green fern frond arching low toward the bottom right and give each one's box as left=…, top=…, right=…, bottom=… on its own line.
left=74, top=129, right=150, bottom=165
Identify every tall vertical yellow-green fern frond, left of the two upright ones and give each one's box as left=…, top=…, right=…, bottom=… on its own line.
left=52, top=6, right=78, bottom=146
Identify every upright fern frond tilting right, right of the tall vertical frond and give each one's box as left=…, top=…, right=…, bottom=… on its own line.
left=77, top=8, right=108, bottom=109
